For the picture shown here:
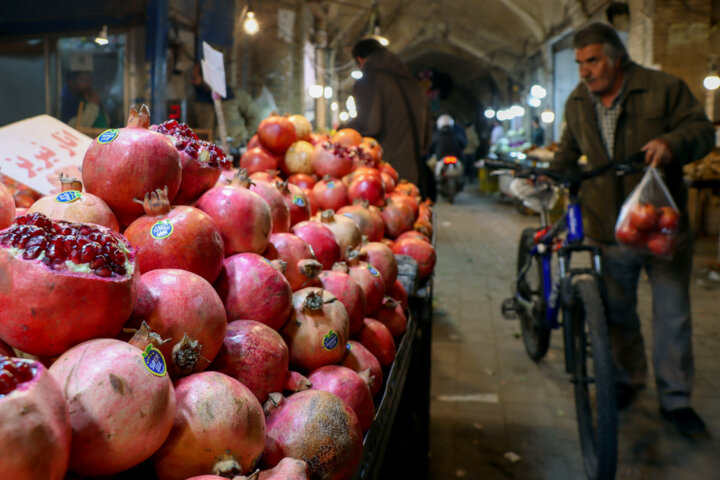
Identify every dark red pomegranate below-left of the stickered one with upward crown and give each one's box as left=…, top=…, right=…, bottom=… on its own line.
left=211, top=320, right=290, bottom=403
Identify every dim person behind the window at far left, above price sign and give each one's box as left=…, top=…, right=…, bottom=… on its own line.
left=60, top=71, right=110, bottom=128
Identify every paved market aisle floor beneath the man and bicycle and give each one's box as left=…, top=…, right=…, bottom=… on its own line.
left=429, top=186, right=720, bottom=480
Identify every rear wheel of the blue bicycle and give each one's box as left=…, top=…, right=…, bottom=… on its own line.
left=517, top=228, right=551, bottom=362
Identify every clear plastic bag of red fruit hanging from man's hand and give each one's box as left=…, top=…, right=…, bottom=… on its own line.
left=615, top=167, right=680, bottom=257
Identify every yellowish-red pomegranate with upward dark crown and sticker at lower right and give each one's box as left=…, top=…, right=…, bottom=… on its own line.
left=280, top=287, right=349, bottom=371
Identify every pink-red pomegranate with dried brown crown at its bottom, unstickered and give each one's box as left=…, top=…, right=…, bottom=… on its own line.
left=125, top=268, right=227, bottom=379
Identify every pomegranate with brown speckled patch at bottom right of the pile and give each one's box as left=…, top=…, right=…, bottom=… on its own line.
left=262, top=390, right=363, bottom=480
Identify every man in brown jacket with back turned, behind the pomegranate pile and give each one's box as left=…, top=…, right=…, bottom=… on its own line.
left=341, top=38, right=436, bottom=199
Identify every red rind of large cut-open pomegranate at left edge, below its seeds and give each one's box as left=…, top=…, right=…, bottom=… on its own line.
left=0, top=223, right=140, bottom=356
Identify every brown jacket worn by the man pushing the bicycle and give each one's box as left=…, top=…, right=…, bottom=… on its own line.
left=553, top=62, right=715, bottom=243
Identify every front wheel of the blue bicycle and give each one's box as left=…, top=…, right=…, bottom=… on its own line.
left=564, top=275, right=617, bottom=480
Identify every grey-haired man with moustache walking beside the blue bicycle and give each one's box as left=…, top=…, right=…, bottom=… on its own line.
left=553, top=23, right=714, bottom=435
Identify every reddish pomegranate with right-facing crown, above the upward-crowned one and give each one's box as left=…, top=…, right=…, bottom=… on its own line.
left=263, top=233, right=322, bottom=291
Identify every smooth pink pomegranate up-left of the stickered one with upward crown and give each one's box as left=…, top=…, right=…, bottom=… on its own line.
left=215, top=253, right=292, bottom=330
